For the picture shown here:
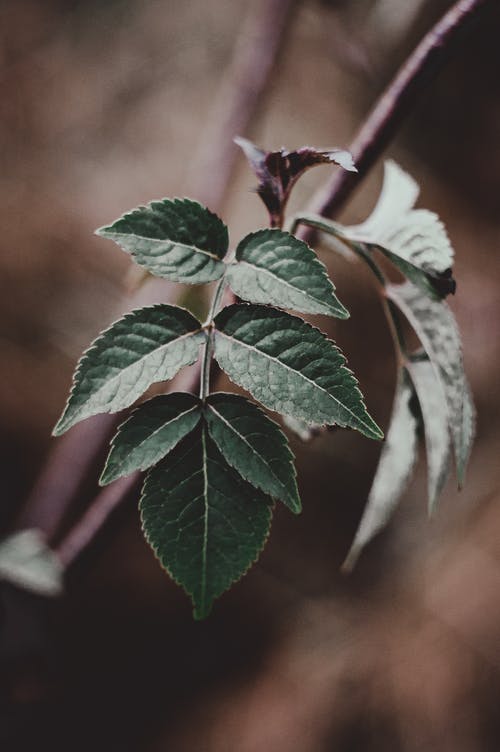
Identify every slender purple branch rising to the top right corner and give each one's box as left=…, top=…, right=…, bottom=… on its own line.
left=301, top=0, right=493, bottom=235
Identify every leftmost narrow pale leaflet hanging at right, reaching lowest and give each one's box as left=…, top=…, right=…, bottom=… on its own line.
left=344, top=372, right=417, bottom=569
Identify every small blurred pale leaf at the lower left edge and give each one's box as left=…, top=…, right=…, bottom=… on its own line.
left=0, top=529, right=63, bottom=597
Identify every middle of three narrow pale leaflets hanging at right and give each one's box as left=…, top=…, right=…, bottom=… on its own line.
left=408, top=360, right=451, bottom=514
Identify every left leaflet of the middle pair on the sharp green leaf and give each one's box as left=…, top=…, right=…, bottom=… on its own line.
left=54, top=305, right=205, bottom=436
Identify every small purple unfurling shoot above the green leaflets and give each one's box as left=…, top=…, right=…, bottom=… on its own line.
left=235, top=138, right=356, bottom=226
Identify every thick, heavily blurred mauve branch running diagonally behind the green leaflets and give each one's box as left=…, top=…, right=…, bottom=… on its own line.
left=15, top=0, right=295, bottom=540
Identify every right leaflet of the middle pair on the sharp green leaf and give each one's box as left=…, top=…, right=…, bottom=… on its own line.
left=215, top=305, right=383, bottom=439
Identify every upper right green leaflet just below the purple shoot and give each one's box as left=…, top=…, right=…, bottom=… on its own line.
left=227, top=230, right=349, bottom=319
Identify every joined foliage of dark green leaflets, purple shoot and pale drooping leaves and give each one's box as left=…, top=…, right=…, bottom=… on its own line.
left=54, top=150, right=474, bottom=618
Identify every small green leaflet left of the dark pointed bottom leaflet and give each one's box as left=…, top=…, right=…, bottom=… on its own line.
left=99, top=392, right=202, bottom=485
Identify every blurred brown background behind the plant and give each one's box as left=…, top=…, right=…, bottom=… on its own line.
left=0, top=0, right=500, bottom=752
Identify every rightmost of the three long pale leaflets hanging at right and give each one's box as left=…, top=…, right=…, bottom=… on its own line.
left=387, top=282, right=475, bottom=485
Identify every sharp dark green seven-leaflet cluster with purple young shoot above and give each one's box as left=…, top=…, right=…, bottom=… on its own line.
left=54, top=150, right=382, bottom=618
